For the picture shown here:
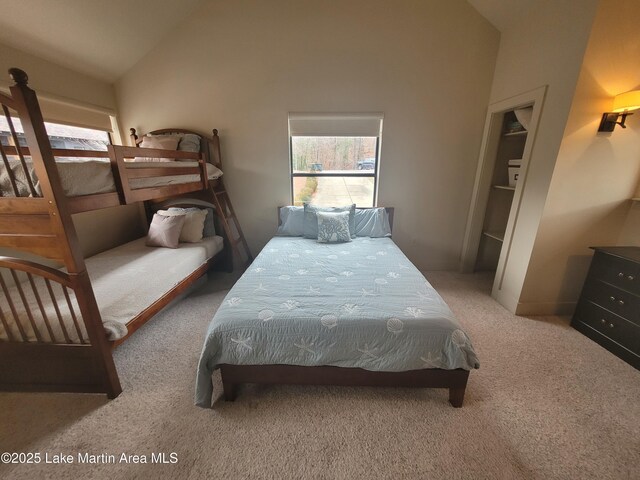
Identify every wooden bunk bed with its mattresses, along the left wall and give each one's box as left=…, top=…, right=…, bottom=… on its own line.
left=0, top=69, right=229, bottom=398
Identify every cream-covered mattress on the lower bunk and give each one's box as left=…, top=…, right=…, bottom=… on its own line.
left=0, top=236, right=223, bottom=343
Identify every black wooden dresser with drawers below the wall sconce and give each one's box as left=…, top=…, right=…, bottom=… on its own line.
left=571, top=247, right=640, bottom=369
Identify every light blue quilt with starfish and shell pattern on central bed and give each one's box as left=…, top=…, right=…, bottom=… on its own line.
left=195, top=237, right=480, bottom=407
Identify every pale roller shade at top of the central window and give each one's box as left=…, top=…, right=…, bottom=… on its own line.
left=289, top=113, right=383, bottom=137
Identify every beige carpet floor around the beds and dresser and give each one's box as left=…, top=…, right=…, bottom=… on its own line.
left=0, top=272, right=640, bottom=480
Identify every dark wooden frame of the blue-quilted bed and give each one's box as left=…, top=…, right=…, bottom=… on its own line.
left=220, top=207, right=469, bottom=408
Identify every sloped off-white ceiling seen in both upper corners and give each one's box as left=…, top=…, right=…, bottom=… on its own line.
left=0, top=0, right=536, bottom=82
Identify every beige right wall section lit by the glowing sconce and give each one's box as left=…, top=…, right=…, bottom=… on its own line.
left=520, top=0, right=640, bottom=314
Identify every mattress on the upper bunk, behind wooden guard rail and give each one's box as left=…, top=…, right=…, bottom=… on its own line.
left=0, top=158, right=222, bottom=197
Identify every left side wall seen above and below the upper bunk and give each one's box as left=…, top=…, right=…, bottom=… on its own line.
left=0, top=44, right=144, bottom=256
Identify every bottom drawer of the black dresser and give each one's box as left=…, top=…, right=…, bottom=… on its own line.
left=575, top=300, right=640, bottom=355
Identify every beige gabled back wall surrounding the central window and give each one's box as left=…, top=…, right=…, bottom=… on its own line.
left=116, top=0, right=499, bottom=269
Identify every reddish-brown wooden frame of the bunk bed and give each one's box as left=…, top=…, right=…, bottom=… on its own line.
left=0, top=69, right=228, bottom=398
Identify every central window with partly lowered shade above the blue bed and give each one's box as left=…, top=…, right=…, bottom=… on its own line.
left=289, top=114, right=382, bottom=207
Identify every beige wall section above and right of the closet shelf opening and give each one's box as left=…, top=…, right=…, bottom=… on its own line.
left=482, top=0, right=597, bottom=313
